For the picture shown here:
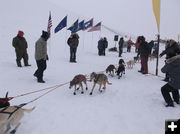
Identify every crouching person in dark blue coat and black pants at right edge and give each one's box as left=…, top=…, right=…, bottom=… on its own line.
left=161, top=55, right=180, bottom=107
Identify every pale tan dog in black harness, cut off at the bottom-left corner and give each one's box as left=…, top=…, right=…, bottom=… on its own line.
left=0, top=106, right=35, bottom=134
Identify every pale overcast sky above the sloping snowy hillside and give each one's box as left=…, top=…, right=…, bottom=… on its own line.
left=49, top=0, right=180, bottom=39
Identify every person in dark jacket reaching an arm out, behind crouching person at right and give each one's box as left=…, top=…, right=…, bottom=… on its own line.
left=159, top=40, right=180, bottom=82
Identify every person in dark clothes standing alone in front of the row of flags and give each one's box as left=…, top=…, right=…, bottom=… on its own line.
left=67, top=33, right=79, bottom=63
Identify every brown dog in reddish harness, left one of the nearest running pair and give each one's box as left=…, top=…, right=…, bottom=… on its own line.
left=69, top=74, right=88, bottom=95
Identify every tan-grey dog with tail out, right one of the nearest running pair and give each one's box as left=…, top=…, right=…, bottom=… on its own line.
left=90, top=72, right=112, bottom=95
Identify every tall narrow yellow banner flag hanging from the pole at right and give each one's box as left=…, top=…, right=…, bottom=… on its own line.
left=152, top=0, right=161, bottom=33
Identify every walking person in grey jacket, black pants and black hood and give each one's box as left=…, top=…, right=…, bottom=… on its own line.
left=34, top=31, right=49, bottom=83
